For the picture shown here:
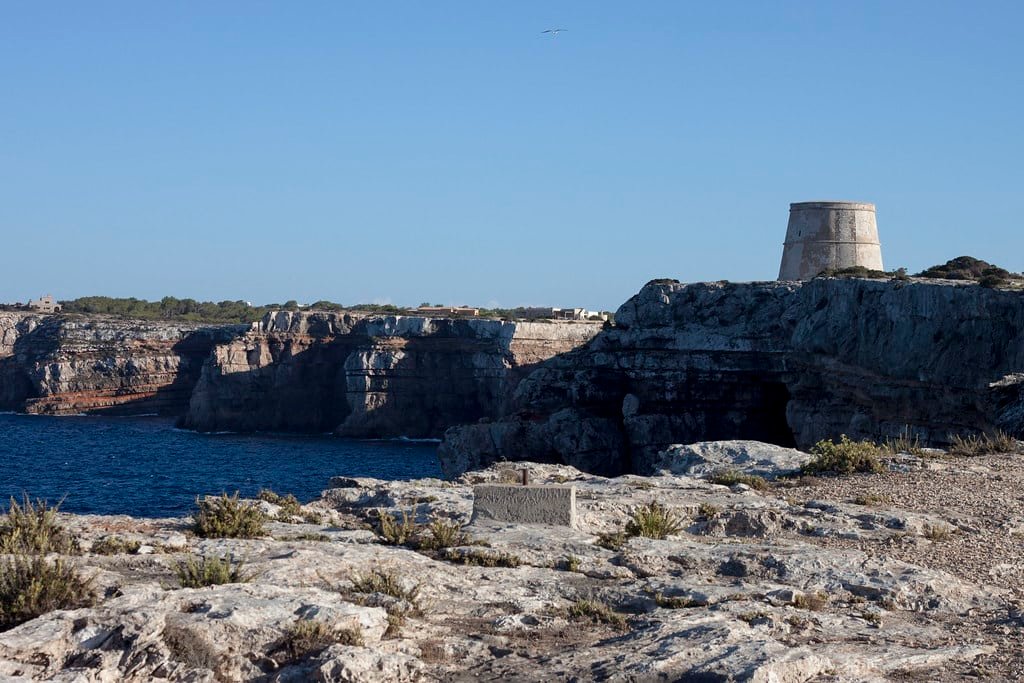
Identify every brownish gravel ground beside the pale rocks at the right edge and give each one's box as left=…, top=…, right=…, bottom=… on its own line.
left=779, top=454, right=1024, bottom=681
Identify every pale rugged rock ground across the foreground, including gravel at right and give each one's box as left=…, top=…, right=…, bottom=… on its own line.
left=0, top=441, right=1024, bottom=681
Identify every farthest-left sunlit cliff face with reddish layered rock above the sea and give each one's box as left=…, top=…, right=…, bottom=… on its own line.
left=0, top=313, right=245, bottom=415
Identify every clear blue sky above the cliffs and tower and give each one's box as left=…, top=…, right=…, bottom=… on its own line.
left=0, top=0, right=1024, bottom=308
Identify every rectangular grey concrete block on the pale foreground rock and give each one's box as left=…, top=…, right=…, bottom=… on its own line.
left=471, top=484, right=577, bottom=526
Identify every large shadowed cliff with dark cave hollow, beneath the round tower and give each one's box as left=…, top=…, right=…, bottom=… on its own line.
left=441, top=279, right=1024, bottom=473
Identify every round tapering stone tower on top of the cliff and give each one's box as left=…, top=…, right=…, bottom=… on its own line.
left=778, top=202, right=883, bottom=280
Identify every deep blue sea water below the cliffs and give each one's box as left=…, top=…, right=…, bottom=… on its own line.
left=0, top=415, right=440, bottom=517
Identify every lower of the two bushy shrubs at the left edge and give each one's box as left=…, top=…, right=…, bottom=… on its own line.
left=0, top=554, right=96, bottom=631
